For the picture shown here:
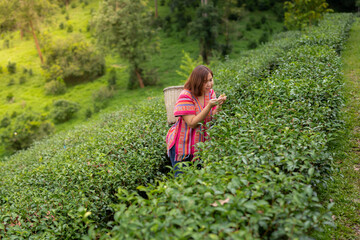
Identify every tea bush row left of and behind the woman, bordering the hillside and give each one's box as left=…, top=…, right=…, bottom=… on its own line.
left=0, top=100, right=167, bottom=239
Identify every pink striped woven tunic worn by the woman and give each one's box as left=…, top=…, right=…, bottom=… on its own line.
left=166, top=89, right=216, bottom=161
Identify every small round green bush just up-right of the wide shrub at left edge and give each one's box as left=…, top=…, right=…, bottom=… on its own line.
left=51, top=99, right=79, bottom=123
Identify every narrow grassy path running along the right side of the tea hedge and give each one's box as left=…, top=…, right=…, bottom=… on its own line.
left=317, top=18, right=360, bottom=240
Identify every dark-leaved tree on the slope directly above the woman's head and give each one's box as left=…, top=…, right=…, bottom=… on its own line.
left=190, top=0, right=221, bottom=64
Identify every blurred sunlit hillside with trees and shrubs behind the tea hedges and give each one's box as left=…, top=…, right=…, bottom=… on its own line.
left=0, top=0, right=360, bottom=157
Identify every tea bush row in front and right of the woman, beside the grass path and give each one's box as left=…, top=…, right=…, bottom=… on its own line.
left=87, top=14, right=352, bottom=239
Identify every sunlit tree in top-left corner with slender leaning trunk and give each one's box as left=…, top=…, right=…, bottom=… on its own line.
left=0, top=0, right=55, bottom=64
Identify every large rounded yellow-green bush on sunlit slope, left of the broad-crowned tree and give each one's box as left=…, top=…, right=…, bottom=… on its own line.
left=43, top=34, right=105, bottom=84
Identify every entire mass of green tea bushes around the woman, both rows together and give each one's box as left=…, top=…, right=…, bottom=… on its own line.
left=0, top=14, right=353, bottom=239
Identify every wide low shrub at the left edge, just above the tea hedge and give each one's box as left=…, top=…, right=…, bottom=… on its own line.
left=1, top=112, right=54, bottom=151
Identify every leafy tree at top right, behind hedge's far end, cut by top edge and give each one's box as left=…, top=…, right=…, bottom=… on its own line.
left=284, top=0, right=332, bottom=29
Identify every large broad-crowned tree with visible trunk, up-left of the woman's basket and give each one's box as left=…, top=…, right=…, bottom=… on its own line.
left=94, top=0, right=158, bottom=88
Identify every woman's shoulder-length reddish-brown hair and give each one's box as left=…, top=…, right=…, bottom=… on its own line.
left=184, top=65, right=213, bottom=96
